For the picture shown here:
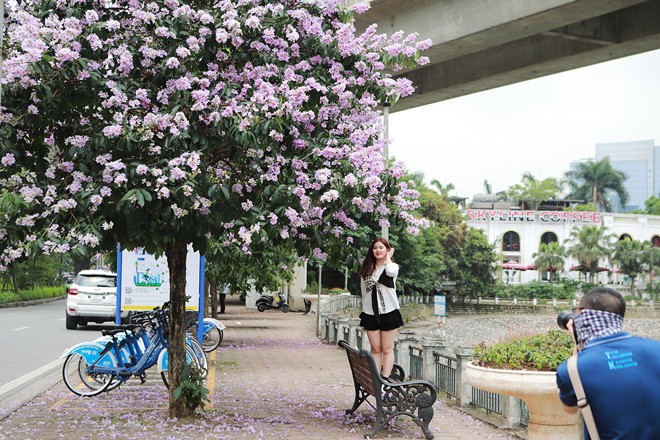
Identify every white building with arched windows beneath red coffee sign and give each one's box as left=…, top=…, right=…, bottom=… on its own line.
left=465, top=209, right=660, bottom=283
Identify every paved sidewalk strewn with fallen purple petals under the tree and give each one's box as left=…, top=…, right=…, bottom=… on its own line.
left=0, top=298, right=516, bottom=440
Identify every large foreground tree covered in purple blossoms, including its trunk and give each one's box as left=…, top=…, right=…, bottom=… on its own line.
left=0, top=0, right=429, bottom=417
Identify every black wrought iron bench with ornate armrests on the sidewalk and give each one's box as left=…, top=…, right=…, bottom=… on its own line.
left=338, top=341, right=437, bottom=439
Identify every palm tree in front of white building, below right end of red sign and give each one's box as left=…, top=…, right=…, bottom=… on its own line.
left=567, top=226, right=614, bottom=283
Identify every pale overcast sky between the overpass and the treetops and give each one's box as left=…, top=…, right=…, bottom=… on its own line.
left=389, top=50, right=660, bottom=198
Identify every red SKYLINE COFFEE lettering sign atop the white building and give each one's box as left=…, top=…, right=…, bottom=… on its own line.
left=465, top=209, right=602, bottom=224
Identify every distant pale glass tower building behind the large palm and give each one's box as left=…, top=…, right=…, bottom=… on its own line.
left=596, top=140, right=660, bottom=212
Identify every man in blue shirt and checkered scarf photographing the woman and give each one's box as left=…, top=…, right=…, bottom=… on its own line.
left=557, top=287, right=660, bottom=440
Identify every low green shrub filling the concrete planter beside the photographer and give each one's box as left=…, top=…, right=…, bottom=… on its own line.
left=472, top=330, right=574, bottom=371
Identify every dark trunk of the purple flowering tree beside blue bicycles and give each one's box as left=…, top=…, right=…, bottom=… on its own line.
left=165, top=241, right=192, bottom=418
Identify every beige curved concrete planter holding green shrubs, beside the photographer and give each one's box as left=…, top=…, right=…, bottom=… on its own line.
left=466, top=362, right=579, bottom=440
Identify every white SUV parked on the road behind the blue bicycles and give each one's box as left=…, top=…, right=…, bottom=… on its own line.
left=66, top=270, right=128, bottom=330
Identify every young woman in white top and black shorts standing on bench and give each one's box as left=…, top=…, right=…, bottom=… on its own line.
left=359, top=238, right=403, bottom=378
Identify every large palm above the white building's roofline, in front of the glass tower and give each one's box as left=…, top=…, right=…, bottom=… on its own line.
left=566, top=157, right=628, bottom=211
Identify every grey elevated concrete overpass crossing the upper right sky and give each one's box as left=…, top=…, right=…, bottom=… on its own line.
left=349, top=0, right=660, bottom=111
